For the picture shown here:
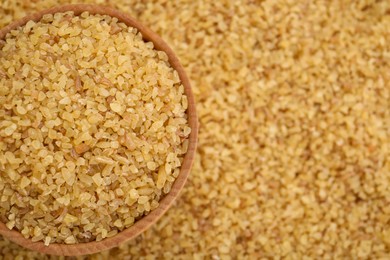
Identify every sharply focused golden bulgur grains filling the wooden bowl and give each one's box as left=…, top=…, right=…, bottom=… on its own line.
left=0, top=12, right=191, bottom=245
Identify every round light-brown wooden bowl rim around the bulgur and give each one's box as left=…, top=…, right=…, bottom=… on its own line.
left=0, top=4, right=198, bottom=256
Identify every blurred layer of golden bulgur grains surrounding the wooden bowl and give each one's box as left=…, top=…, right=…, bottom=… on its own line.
left=0, top=0, right=390, bottom=259
